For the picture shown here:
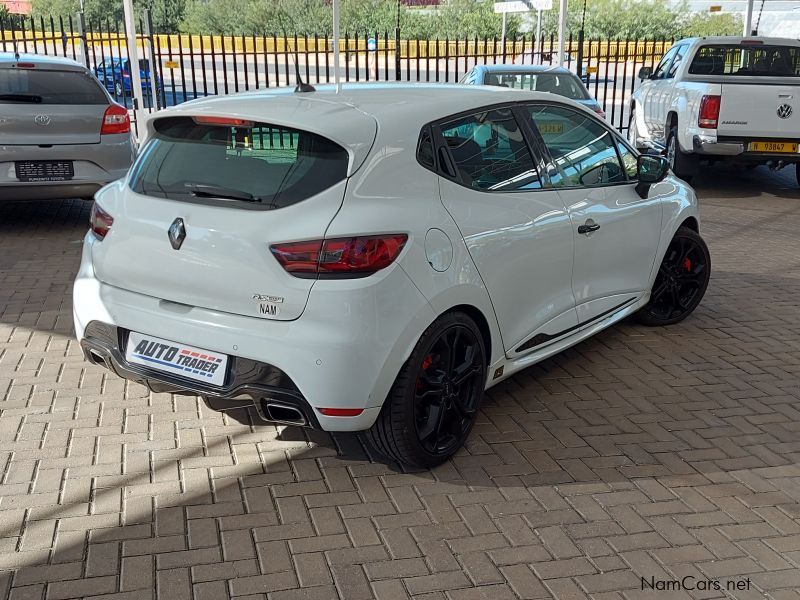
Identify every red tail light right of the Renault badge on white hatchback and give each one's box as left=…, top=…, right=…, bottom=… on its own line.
left=270, top=234, right=408, bottom=277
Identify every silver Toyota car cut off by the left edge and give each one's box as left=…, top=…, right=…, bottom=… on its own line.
left=0, top=53, right=135, bottom=201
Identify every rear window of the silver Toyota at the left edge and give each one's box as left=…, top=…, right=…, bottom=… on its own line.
left=0, top=68, right=108, bottom=104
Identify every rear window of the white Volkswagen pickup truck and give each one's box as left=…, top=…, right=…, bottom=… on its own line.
left=689, top=45, right=800, bottom=77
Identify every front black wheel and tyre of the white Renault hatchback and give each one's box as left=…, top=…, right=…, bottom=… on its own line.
left=636, top=227, right=711, bottom=327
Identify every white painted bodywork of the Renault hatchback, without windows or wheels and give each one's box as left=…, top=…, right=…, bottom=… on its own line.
left=74, top=84, right=698, bottom=431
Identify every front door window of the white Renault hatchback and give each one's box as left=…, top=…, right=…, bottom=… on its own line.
left=528, top=105, right=627, bottom=187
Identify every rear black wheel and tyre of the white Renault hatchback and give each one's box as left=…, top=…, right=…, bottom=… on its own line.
left=365, top=312, right=487, bottom=468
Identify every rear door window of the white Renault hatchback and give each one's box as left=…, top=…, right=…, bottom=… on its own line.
left=441, top=108, right=542, bottom=192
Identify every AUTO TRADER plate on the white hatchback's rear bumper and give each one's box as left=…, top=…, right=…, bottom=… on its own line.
left=125, top=331, right=228, bottom=385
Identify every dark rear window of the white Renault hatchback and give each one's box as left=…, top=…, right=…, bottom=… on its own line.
left=130, top=117, right=348, bottom=209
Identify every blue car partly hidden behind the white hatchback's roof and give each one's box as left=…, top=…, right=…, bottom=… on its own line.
left=459, top=64, right=606, bottom=118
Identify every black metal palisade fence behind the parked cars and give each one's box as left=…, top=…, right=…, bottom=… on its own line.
left=0, top=15, right=673, bottom=135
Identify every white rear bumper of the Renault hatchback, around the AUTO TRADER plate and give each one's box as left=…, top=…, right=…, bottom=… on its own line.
left=73, top=235, right=435, bottom=431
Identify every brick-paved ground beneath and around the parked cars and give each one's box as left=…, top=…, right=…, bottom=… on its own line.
left=0, top=169, right=800, bottom=600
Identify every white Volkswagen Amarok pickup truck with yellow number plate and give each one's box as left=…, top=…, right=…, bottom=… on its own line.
left=628, top=37, right=800, bottom=182
